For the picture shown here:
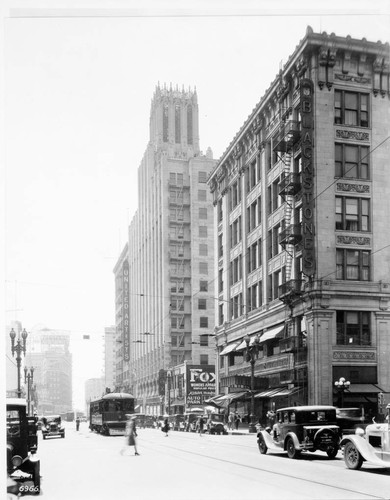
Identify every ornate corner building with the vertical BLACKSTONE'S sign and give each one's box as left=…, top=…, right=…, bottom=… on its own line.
left=208, top=28, right=390, bottom=420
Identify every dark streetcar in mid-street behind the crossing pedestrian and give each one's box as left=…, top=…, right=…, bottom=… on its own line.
left=89, top=392, right=135, bottom=436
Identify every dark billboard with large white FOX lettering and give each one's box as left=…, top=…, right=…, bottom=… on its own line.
left=186, top=365, right=215, bottom=409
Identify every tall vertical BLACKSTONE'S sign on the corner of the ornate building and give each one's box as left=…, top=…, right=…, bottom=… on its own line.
left=300, top=78, right=315, bottom=277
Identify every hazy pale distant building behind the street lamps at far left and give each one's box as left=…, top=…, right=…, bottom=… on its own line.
left=25, top=328, right=72, bottom=415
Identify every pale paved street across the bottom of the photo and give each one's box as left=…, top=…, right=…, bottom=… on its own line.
left=25, top=423, right=390, bottom=500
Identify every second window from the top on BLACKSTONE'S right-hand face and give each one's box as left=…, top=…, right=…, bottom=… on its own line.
left=335, top=144, right=370, bottom=179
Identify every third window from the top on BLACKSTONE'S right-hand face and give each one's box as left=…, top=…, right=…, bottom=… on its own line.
left=336, top=196, right=370, bottom=231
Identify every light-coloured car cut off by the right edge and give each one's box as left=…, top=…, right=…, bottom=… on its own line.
left=341, top=404, right=390, bottom=470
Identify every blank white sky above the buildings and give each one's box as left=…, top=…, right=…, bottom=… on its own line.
left=0, top=0, right=390, bottom=403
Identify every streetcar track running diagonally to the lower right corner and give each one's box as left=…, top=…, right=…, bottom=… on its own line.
left=138, top=436, right=386, bottom=500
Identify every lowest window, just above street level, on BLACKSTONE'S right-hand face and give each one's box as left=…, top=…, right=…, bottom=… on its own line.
left=336, top=311, right=371, bottom=345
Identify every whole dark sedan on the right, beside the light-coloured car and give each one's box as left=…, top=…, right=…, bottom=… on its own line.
left=257, top=406, right=341, bottom=458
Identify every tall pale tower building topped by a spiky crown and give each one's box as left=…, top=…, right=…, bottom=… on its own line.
left=115, top=86, right=215, bottom=414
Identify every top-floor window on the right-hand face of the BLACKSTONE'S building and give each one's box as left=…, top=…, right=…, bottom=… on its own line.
left=334, top=90, right=369, bottom=127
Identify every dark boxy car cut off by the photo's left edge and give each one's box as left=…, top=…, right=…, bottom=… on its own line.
left=6, top=398, right=41, bottom=494
